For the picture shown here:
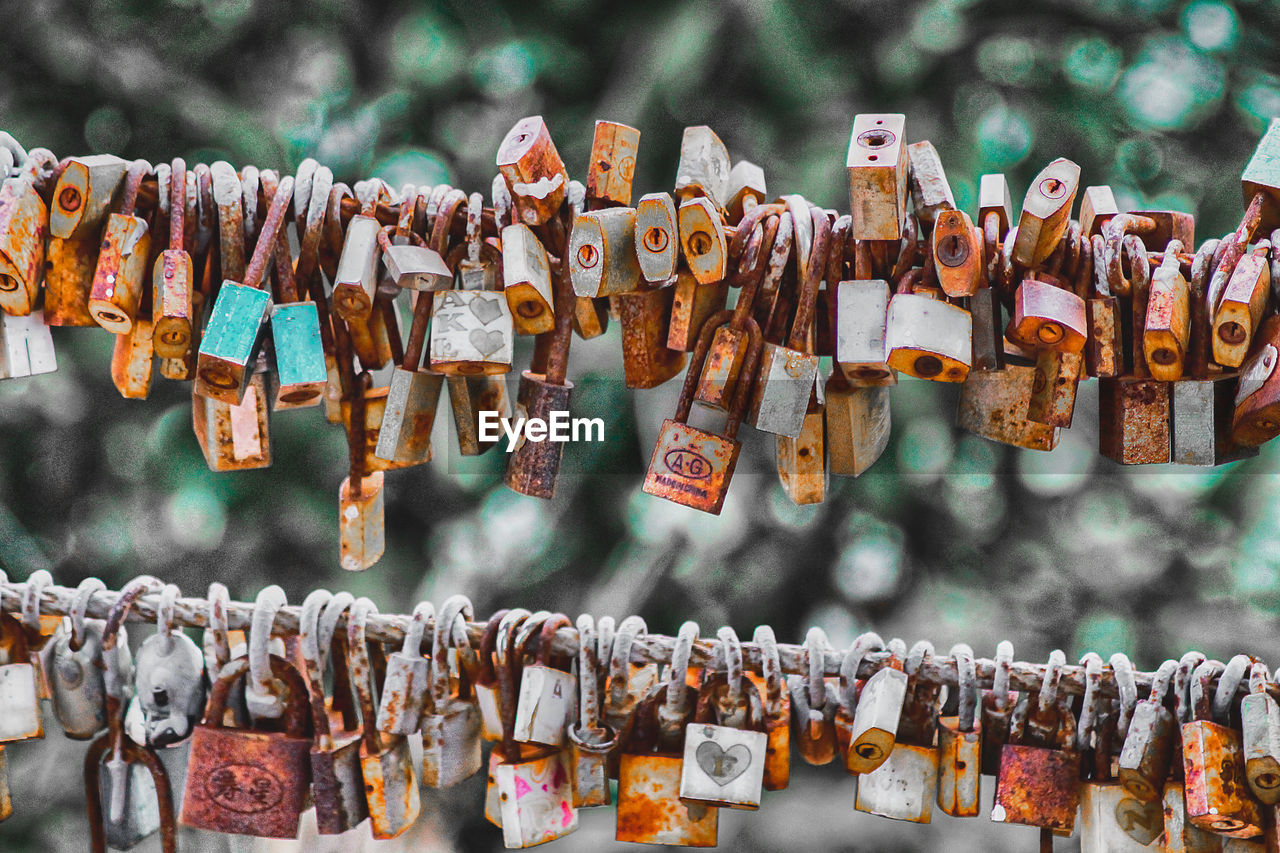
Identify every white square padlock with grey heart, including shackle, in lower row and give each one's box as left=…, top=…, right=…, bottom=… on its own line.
left=680, top=626, right=769, bottom=811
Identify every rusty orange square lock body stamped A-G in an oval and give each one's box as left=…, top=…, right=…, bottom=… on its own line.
left=644, top=419, right=742, bottom=515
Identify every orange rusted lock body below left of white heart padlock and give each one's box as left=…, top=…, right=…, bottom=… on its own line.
left=616, top=753, right=719, bottom=847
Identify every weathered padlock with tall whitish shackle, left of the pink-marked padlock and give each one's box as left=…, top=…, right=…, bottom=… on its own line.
left=421, top=596, right=483, bottom=788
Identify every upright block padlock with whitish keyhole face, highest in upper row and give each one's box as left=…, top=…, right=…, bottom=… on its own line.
left=845, top=113, right=909, bottom=241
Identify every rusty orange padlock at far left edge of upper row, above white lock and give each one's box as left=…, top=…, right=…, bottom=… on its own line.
left=0, top=149, right=56, bottom=316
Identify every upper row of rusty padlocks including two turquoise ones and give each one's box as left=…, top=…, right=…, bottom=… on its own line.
left=0, top=114, right=1280, bottom=548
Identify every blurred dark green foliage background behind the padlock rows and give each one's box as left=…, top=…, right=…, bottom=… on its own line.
left=0, top=0, right=1280, bottom=850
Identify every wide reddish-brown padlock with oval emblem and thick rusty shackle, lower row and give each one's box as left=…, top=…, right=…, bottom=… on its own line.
left=179, top=656, right=311, bottom=838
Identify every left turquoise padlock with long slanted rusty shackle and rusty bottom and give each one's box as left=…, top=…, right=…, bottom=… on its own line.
left=195, top=175, right=293, bottom=406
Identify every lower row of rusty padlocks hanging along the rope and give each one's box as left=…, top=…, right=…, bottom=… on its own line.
left=0, top=571, right=1280, bottom=853
